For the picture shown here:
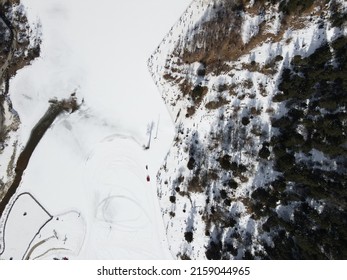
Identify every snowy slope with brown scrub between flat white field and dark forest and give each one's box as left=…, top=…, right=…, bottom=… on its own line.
left=148, top=0, right=346, bottom=259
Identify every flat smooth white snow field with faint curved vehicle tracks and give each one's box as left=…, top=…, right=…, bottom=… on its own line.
left=0, top=0, right=189, bottom=259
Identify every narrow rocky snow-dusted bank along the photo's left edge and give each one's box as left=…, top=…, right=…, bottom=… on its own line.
left=0, top=0, right=41, bottom=201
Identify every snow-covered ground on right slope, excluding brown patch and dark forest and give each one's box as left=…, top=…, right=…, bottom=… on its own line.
left=149, top=0, right=346, bottom=259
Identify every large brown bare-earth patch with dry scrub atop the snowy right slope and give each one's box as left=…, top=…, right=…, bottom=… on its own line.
left=174, top=0, right=324, bottom=75
